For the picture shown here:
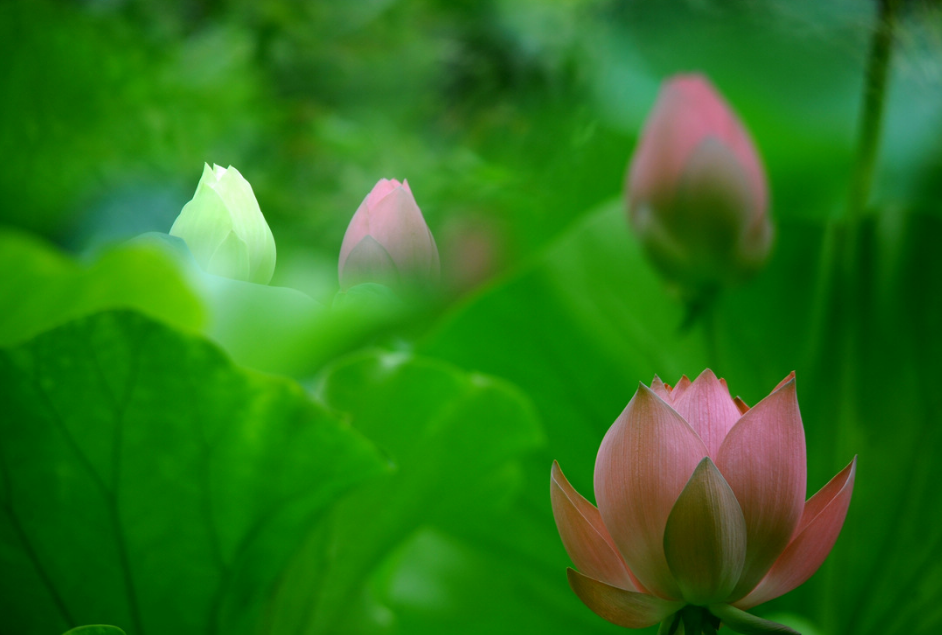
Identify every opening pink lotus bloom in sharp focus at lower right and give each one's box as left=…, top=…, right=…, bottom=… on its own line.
left=551, top=370, right=857, bottom=635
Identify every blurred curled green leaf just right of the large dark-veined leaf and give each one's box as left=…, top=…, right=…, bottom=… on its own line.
left=266, top=352, right=542, bottom=634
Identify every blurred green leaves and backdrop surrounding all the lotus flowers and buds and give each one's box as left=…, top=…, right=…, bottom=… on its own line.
left=0, top=0, right=942, bottom=635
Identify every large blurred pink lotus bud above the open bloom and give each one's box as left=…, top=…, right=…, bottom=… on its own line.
left=627, top=75, right=772, bottom=294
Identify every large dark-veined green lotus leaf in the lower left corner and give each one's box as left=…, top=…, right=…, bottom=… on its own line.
left=0, top=312, right=382, bottom=635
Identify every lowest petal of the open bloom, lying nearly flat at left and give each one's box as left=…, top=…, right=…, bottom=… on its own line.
left=566, top=569, right=684, bottom=628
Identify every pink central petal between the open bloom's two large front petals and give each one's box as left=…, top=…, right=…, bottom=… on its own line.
left=674, top=369, right=741, bottom=457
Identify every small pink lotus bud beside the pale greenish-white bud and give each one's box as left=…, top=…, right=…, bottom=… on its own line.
left=340, top=179, right=441, bottom=290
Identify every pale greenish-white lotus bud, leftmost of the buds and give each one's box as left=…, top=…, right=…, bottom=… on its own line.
left=170, top=164, right=275, bottom=284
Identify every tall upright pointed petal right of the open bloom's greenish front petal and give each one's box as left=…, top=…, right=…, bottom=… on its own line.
left=716, top=378, right=807, bottom=600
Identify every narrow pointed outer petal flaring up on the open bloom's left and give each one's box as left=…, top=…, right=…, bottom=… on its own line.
left=550, top=461, right=642, bottom=591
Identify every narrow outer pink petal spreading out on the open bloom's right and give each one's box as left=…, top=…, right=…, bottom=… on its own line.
left=736, top=457, right=857, bottom=609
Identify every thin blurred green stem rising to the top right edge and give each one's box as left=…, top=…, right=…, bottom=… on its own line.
left=847, top=0, right=900, bottom=222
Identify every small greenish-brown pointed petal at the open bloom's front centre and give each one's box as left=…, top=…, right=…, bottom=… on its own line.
left=664, top=457, right=746, bottom=606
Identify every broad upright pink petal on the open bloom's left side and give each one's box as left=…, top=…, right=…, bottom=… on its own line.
left=595, top=384, right=706, bottom=599
